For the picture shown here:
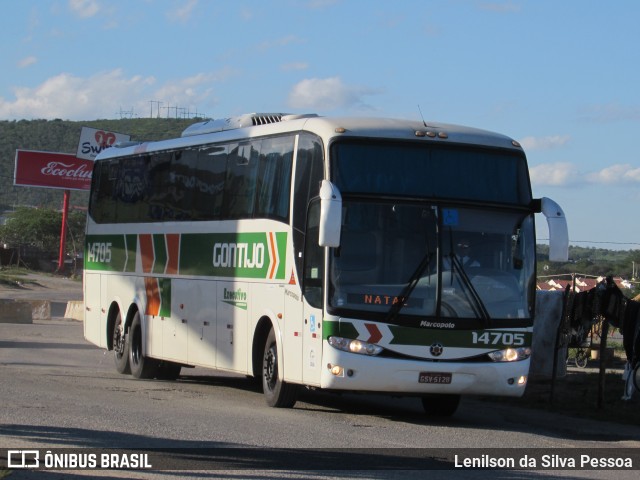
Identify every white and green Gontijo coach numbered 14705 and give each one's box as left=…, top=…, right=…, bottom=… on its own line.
left=84, top=114, right=568, bottom=415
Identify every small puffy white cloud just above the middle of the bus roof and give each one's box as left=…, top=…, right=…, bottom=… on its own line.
left=288, top=77, right=378, bottom=111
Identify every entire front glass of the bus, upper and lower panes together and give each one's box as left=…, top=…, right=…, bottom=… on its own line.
left=328, top=139, right=535, bottom=328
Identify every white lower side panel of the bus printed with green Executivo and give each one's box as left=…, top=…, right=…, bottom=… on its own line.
left=216, top=282, right=248, bottom=372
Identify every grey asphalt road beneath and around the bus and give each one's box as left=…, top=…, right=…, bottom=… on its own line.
left=0, top=276, right=640, bottom=480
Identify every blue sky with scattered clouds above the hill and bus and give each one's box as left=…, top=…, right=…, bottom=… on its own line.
left=0, top=0, right=640, bottom=250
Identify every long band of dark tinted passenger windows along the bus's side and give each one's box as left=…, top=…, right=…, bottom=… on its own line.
left=90, top=135, right=294, bottom=223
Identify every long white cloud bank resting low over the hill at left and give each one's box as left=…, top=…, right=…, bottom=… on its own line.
left=0, top=69, right=225, bottom=120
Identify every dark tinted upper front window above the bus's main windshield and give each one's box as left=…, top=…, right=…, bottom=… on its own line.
left=332, top=142, right=531, bottom=204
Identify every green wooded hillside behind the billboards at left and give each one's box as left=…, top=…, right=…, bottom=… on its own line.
left=0, top=118, right=197, bottom=212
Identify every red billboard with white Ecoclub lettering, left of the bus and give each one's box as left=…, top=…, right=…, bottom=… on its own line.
left=13, top=150, right=93, bottom=190
